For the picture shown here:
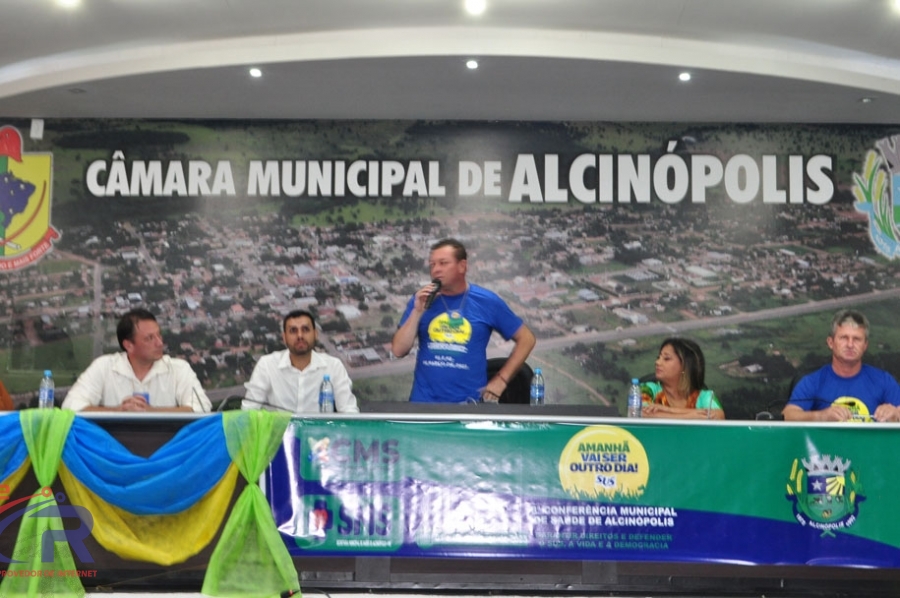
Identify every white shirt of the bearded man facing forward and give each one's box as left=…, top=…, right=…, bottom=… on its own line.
left=241, top=349, right=359, bottom=413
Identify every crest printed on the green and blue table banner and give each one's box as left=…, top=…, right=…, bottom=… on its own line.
left=787, top=455, right=865, bottom=536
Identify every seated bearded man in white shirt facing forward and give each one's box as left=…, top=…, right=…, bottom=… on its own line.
left=241, top=310, right=359, bottom=413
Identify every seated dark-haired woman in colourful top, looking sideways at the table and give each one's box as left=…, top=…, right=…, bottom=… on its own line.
left=641, top=338, right=725, bottom=419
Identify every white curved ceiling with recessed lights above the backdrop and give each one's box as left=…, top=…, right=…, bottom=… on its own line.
left=0, top=0, right=900, bottom=124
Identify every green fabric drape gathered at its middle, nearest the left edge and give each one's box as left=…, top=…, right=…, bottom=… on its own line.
left=0, top=409, right=84, bottom=598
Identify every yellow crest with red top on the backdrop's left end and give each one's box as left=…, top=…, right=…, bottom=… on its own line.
left=0, top=126, right=59, bottom=270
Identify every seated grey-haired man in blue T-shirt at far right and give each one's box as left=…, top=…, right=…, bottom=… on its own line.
left=782, top=309, right=900, bottom=422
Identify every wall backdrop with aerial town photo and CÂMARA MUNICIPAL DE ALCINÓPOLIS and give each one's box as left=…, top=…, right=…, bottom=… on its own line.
left=8, top=118, right=900, bottom=420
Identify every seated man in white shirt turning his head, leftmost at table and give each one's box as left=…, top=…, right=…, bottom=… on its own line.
left=62, top=309, right=210, bottom=413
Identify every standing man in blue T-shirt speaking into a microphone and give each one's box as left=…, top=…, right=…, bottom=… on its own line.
left=391, top=239, right=535, bottom=403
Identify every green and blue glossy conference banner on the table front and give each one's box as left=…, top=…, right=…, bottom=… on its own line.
left=263, top=418, right=900, bottom=567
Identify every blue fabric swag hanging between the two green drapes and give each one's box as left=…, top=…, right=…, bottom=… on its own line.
left=62, top=414, right=231, bottom=515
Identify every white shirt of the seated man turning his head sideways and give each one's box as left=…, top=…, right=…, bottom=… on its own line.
left=62, top=352, right=211, bottom=413
